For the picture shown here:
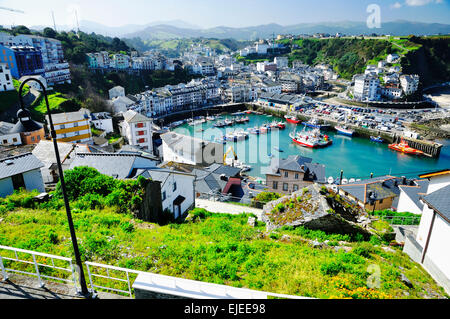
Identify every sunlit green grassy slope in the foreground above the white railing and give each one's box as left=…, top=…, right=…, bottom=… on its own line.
left=0, top=208, right=442, bottom=298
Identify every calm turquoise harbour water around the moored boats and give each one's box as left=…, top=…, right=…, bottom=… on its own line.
left=174, top=114, right=450, bottom=179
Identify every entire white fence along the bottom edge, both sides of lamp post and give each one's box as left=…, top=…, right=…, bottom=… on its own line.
left=0, top=246, right=309, bottom=299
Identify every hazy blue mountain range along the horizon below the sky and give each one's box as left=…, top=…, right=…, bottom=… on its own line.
left=32, top=20, right=450, bottom=40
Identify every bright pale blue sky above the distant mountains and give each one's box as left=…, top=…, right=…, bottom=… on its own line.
left=0, top=0, right=450, bottom=28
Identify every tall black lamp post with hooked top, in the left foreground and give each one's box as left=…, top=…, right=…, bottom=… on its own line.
left=19, top=78, right=91, bottom=298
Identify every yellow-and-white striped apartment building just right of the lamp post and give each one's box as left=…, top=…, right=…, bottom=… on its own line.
left=46, top=109, right=93, bottom=144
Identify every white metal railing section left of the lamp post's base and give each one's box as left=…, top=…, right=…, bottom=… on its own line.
left=0, top=245, right=79, bottom=291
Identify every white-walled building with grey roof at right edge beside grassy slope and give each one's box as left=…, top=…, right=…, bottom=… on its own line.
left=404, top=169, right=450, bottom=293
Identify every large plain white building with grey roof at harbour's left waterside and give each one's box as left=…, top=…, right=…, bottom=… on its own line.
left=161, top=132, right=224, bottom=165
